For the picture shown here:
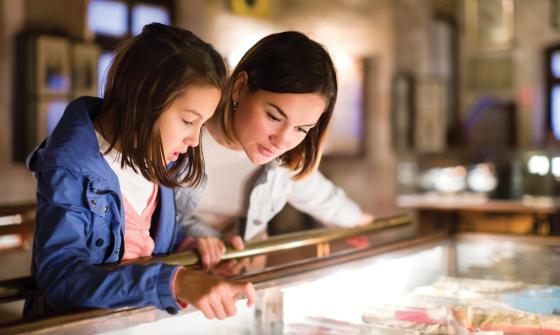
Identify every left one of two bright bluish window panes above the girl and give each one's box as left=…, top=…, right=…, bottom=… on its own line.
left=88, top=0, right=128, bottom=37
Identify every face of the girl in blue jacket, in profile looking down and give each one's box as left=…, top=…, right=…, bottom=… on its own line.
left=157, top=86, right=220, bottom=163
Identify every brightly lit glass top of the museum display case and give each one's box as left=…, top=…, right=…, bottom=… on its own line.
left=94, top=235, right=560, bottom=335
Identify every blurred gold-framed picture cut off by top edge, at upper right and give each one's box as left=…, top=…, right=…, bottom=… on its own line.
left=464, top=0, right=514, bottom=49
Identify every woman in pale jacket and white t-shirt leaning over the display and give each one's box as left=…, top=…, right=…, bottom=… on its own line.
left=175, top=32, right=373, bottom=266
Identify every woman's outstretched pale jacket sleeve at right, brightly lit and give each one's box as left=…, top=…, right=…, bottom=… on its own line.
left=288, top=170, right=362, bottom=227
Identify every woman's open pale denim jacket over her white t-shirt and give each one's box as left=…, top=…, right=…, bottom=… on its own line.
left=175, top=162, right=362, bottom=241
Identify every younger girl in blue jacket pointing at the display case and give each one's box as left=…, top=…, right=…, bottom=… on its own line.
left=24, top=24, right=254, bottom=319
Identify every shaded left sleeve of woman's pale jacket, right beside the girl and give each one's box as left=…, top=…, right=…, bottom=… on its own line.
left=175, top=177, right=221, bottom=238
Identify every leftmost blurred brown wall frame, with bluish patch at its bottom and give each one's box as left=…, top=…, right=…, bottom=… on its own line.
left=32, top=35, right=71, bottom=97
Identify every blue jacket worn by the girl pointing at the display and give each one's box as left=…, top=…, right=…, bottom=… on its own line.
left=24, top=97, right=185, bottom=316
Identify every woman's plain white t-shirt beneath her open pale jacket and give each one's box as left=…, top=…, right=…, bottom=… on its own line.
left=194, top=130, right=261, bottom=232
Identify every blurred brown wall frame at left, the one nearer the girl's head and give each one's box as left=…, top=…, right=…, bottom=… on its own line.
left=72, top=42, right=101, bottom=98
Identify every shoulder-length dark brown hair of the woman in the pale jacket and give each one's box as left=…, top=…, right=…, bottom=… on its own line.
left=216, top=31, right=338, bottom=179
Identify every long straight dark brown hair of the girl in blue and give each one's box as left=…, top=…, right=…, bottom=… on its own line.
left=101, top=23, right=226, bottom=187
